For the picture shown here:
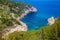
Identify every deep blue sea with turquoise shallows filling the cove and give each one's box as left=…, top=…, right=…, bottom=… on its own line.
left=14, top=0, right=60, bottom=30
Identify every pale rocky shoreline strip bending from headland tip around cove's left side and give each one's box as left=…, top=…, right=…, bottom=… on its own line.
left=16, top=6, right=37, bottom=31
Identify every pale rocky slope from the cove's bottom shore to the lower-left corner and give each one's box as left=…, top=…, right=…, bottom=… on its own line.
left=2, top=21, right=27, bottom=39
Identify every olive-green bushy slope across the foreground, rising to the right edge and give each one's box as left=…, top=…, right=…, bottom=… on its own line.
left=7, top=17, right=60, bottom=40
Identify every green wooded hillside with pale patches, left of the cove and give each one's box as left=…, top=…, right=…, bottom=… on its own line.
left=0, top=0, right=27, bottom=31
